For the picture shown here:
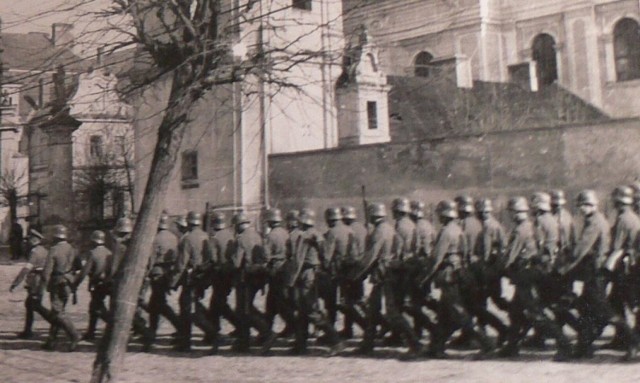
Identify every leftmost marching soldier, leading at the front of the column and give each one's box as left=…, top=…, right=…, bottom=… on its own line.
left=9, top=229, right=51, bottom=339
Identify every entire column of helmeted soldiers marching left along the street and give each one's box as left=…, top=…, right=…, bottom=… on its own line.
left=11, top=185, right=640, bottom=361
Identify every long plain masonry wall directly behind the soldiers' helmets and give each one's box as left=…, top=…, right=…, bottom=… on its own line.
left=269, top=119, right=640, bottom=225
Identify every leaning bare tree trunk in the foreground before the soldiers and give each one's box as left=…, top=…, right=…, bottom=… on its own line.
left=91, top=70, right=195, bottom=383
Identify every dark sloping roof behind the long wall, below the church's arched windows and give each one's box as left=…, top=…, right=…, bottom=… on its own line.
left=388, top=76, right=608, bottom=142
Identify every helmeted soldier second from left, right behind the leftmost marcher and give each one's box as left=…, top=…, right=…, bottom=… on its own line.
left=40, top=225, right=82, bottom=351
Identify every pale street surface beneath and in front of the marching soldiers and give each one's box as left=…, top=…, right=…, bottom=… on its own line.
left=0, top=266, right=640, bottom=383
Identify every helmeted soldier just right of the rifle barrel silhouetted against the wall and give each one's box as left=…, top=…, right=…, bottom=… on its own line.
left=355, top=204, right=422, bottom=359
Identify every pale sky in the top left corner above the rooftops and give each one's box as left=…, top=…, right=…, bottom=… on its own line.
left=0, top=0, right=131, bottom=56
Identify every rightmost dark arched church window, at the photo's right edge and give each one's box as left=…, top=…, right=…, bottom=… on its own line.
left=613, top=19, right=640, bottom=81
